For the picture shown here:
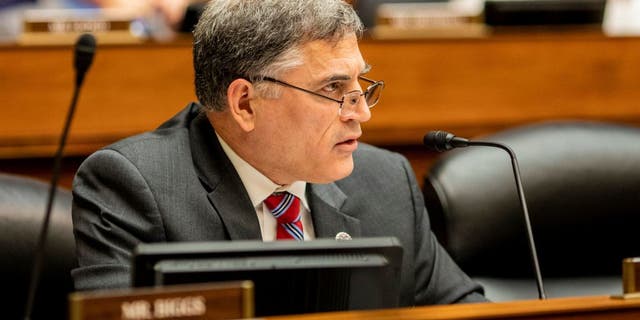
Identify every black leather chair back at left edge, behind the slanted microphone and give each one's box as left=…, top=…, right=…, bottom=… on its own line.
left=0, top=174, right=75, bottom=319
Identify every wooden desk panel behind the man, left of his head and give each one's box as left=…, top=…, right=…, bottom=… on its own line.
left=0, top=45, right=195, bottom=158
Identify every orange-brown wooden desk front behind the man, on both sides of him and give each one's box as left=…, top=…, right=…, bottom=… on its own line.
left=0, top=33, right=640, bottom=181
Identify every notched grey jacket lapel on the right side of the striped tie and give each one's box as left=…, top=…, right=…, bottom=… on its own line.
left=307, top=183, right=361, bottom=238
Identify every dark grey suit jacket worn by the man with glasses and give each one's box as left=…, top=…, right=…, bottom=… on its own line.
left=72, top=104, right=484, bottom=306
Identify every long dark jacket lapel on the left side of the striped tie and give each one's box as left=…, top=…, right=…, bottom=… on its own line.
left=189, top=114, right=262, bottom=240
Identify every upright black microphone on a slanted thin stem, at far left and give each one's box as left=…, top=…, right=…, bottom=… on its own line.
left=24, top=34, right=96, bottom=320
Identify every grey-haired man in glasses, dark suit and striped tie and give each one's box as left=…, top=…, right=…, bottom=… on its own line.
left=72, top=0, right=485, bottom=306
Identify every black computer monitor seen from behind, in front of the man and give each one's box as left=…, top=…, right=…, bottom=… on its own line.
left=132, top=238, right=402, bottom=316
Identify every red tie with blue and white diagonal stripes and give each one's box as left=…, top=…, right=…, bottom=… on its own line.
left=264, top=192, right=304, bottom=240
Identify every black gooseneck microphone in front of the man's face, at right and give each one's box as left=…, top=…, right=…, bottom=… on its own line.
left=423, top=131, right=547, bottom=300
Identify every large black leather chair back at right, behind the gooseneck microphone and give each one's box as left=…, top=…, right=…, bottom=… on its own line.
left=423, top=121, right=640, bottom=300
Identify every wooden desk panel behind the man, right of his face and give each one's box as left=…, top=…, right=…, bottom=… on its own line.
left=361, top=35, right=640, bottom=144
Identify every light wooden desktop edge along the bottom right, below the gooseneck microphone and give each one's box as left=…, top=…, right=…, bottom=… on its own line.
left=266, top=296, right=640, bottom=320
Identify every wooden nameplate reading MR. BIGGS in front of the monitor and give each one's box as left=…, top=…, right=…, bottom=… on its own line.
left=69, top=281, right=254, bottom=320
